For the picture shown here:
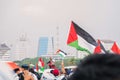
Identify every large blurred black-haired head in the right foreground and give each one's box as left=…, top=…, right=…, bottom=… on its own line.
left=68, top=53, right=120, bottom=80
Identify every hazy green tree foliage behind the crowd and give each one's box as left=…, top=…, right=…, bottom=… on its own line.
left=14, top=57, right=80, bottom=68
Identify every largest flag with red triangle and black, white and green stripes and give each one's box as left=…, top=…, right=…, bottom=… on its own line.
left=67, top=21, right=107, bottom=53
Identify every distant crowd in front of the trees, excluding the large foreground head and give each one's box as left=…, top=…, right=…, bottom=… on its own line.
left=14, top=58, right=72, bottom=80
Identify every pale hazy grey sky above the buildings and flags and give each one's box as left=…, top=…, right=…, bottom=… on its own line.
left=0, top=0, right=120, bottom=56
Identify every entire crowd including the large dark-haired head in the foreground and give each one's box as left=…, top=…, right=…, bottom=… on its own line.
left=14, top=53, right=120, bottom=80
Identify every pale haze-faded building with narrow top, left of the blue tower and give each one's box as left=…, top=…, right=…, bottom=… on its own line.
left=14, top=34, right=31, bottom=60
